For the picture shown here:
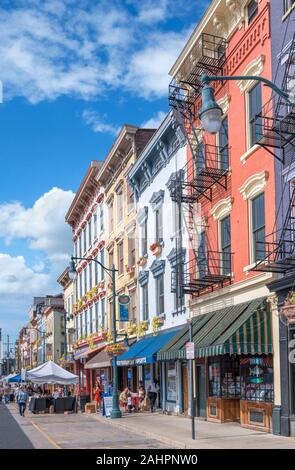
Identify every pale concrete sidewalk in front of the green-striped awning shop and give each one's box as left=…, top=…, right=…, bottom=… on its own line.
left=88, top=413, right=295, bottom=449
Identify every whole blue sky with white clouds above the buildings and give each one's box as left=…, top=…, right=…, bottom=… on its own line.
left=0, top=0, right=210, bottom=341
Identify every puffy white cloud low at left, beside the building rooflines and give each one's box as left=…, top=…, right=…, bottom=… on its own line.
left=0, top=188, right=74, bottom=259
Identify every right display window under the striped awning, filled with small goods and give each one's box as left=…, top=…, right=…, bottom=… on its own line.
left=240, top=356, right=274, bottom=402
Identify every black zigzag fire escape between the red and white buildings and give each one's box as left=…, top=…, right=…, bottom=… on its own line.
left=169, top=34, right=232, bottom=296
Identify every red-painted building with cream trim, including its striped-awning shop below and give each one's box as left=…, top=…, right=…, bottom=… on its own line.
left=162, top=0, right=281, bottom=431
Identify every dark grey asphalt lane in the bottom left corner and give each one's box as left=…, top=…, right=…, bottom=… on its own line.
left=0, top=402, right=34, bottom=449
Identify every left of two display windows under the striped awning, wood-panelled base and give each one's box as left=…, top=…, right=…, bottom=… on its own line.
left=209, top=355, right=240, bottom=398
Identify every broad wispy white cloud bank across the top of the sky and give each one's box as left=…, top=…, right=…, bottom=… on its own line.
left=0, top=0, right=199, bottom=103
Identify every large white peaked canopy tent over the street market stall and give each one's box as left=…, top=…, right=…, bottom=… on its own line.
left=27, top=361, right=79, bottom=385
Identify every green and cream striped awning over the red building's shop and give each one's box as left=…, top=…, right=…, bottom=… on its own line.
left=157, top=297, right=272, bottom=361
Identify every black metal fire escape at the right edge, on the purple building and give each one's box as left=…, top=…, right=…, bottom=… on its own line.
left=253, top=34, right=295, bottom=274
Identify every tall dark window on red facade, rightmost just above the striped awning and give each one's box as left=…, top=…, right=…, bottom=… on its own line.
left=252, top=193, right=265, bottom=262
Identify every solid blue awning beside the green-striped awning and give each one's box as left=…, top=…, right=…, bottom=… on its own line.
left=117, top=329, right=183, bottom=366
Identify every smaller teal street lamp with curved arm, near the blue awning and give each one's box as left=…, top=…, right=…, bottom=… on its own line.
left=68, top=256, right=122, bottom=419
